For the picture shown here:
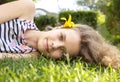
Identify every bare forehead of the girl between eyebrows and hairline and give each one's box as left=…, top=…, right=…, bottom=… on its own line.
left=56, top=29, right=81, bottom=56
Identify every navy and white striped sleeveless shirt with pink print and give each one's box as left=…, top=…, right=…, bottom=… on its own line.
left=0, top=18, right=38, bottom=53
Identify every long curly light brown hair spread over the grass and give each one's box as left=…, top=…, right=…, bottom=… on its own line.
left=75, top=24, right=120, bottom=69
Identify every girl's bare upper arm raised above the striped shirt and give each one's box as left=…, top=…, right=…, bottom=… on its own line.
left=0, top=0, right=35, bottom=23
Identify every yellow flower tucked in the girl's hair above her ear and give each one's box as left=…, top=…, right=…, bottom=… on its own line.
left=60, top=14, right=74, bottom=28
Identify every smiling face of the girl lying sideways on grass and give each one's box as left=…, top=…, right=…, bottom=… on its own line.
left=38, top=29, right=81, bottom=58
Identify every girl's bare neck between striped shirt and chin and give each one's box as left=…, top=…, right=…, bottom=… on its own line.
left=24, top=30, right=42, bottom=49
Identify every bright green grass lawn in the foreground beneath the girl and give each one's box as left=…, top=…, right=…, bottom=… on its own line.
left=0, top=56, right=120, bottom=82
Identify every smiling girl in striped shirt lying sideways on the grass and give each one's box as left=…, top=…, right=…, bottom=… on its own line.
left=0, top=0, right=120, bottom=68
